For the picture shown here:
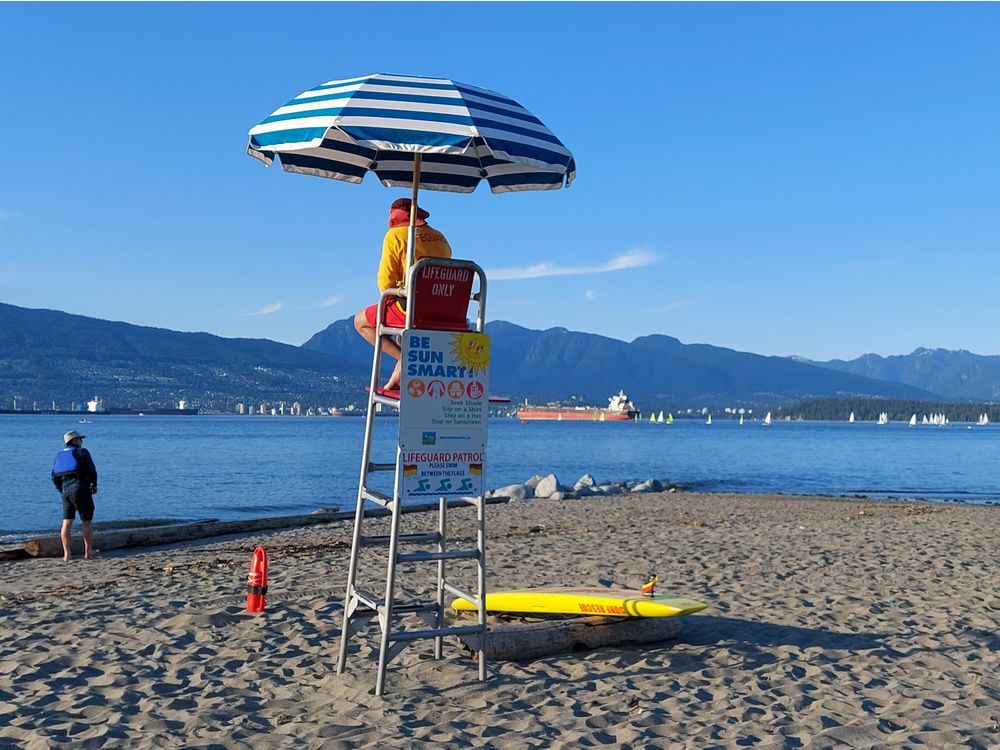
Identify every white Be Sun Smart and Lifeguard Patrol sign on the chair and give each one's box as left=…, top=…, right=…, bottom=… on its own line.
left=399, top=329, right=490, bottom=498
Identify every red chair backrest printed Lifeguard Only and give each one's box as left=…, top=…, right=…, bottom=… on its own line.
left=410, top=258, right=476, bottom=331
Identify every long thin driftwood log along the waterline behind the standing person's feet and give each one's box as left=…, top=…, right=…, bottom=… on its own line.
left=24, top=497, right=509, bottom=557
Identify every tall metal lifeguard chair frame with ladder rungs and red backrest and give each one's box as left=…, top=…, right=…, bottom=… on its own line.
left=337, top=258, right=486, bottom=696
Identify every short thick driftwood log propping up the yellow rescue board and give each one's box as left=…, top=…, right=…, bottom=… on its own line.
left=460, top=613, right=682, bottom=661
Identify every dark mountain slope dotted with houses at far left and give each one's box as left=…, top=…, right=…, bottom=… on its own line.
left=0, top=304, right=370, bottom=412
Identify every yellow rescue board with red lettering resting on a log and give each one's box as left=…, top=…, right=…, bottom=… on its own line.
left=451, top=588, right=708, bottom=617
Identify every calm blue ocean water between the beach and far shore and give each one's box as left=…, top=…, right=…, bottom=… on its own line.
left=0, top=415, right=1000, bottom=540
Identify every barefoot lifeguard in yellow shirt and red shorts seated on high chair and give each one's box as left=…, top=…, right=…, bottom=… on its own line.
left=354, top=198, right=451, bottom=391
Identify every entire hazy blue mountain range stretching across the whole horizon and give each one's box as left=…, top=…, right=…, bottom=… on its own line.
left=0, top=304, right=1000, bottom=412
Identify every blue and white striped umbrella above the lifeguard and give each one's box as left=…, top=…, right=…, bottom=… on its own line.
left=247, top=74, right=576, bottom=193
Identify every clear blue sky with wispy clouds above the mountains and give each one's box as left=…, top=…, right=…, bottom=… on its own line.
left=0, top=3, right=1000, bottom=359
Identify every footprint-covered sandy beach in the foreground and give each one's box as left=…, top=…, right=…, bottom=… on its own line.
left=0, top=493, right=1000, bottom=748
